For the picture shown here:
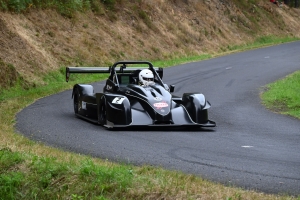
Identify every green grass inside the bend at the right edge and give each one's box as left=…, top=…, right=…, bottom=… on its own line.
left=261, top=71, right=300, bottom=119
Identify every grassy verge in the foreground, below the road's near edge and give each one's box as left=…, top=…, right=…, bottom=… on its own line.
left=0, top=148, right=296, bottom=200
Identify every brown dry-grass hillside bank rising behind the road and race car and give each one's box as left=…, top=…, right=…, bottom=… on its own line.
left=0, top=0, right=300, bottom=91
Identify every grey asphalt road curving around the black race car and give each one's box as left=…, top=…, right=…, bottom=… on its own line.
left=16, top=42, right=300, bottom=195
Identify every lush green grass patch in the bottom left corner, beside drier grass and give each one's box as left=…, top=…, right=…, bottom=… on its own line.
left=0, top=148, right=133, bottom=199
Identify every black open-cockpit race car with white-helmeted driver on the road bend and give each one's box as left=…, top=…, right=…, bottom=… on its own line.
left=66, top=61, right=216, bottom=128
